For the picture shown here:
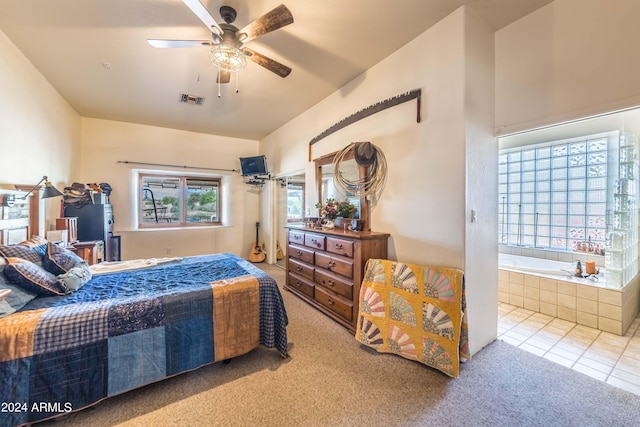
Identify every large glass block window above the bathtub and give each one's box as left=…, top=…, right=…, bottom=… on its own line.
left=498, top=135, right=610, bottom=250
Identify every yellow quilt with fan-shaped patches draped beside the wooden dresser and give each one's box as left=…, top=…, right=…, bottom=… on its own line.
left=356, top=259, right=471, bottom=378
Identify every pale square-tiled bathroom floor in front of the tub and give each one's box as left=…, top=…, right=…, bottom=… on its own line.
left=498, top=303, right=640, bottom=395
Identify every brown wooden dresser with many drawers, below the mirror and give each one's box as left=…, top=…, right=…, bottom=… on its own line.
left=285, top=226, right=389, bottom=332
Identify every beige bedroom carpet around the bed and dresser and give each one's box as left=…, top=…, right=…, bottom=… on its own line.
left=42, top=264, right=640, bottom=426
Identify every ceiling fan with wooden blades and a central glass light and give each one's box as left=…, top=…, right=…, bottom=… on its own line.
left=147, top=0, right=293, bottom=83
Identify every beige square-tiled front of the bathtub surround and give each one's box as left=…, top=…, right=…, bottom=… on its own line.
left=498, top=269, right=640, bottom=335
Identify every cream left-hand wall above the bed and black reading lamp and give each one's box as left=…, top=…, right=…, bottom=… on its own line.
left=0, top=31, right=80, bottom=233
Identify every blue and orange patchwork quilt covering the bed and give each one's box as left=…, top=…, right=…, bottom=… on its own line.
left=0, top=254, right=288, bottom=426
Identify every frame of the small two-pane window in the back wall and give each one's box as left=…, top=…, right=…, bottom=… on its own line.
left=136, top=171, right=223, bottom=230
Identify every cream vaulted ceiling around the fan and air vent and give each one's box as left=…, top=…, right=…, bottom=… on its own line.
left=0, top=0, right=551, bottom=140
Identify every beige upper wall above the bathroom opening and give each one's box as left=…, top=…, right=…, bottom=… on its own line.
left=495, top=0, right=640, bottom=135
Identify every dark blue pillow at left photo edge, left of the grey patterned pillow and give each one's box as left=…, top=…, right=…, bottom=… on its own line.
left=4, top=257, right=65, bottom=295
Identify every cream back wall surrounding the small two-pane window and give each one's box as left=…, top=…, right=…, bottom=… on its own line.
left=76, top=118, right=260, bottom=259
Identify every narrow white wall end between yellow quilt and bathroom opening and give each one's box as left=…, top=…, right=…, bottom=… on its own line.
left=465, top=11, right=498, bottom=358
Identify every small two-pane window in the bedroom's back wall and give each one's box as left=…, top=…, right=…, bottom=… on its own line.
left=138, top=174, right=221, bottom=228
